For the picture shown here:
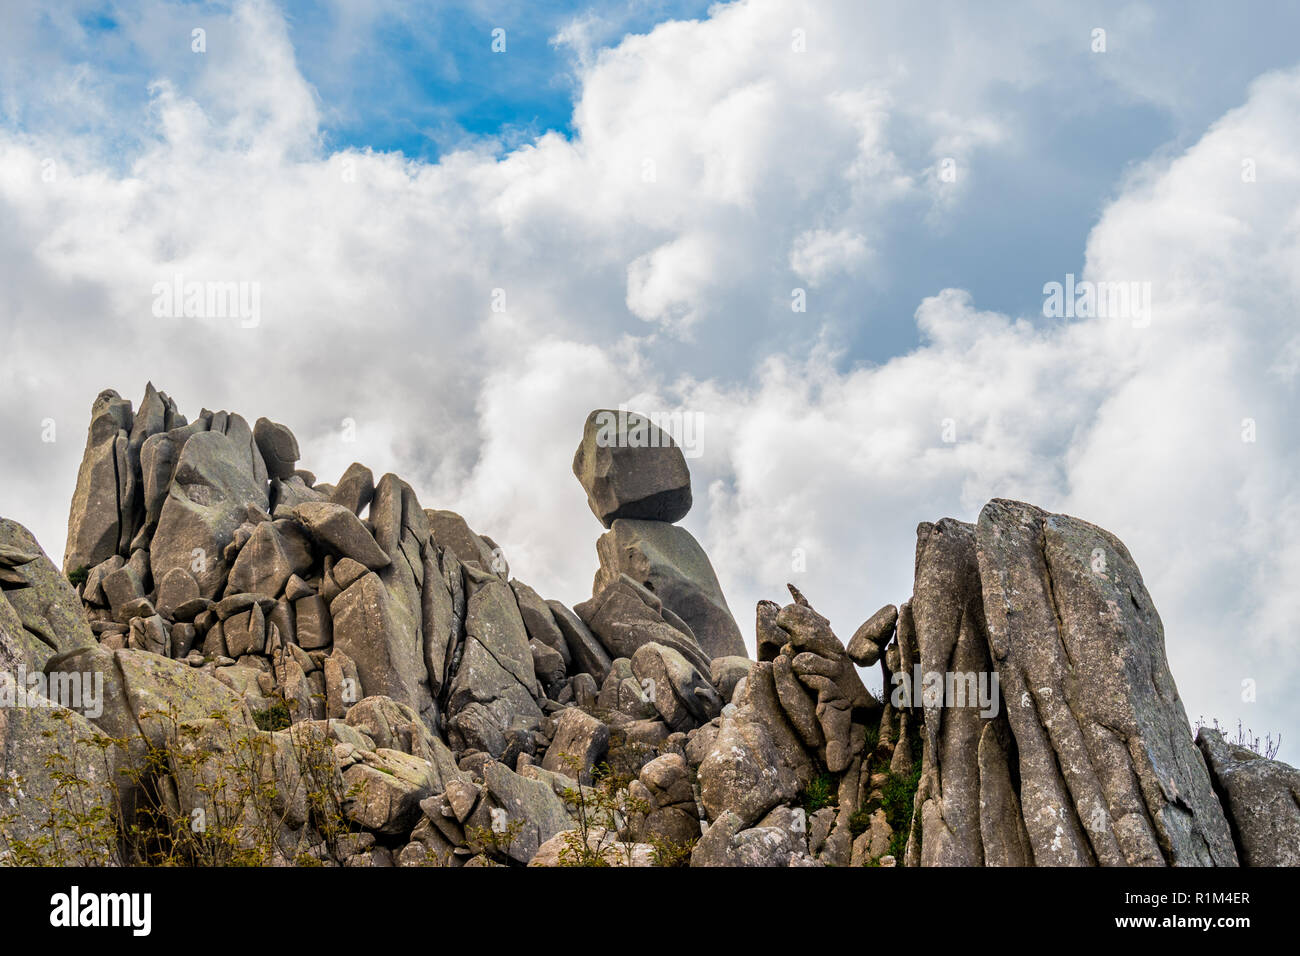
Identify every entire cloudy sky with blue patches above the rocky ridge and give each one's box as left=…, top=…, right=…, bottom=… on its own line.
left=0, top=0, right=1300, bottom=762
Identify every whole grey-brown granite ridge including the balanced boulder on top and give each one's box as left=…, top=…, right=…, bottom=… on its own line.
left=0, top=385, right=1300, bottom=866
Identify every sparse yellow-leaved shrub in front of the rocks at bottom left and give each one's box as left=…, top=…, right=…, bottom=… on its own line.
left=0, top=708, right=348, bottom=866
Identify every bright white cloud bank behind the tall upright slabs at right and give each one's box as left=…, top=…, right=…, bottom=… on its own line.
left=696, top=72, right=1300, bottom=745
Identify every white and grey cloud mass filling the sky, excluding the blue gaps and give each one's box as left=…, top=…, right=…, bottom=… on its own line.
left=0, top=0, right=1300, bottom=759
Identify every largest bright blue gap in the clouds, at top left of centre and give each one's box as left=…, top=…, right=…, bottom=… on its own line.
left=285, top=3, right=709, bottom=160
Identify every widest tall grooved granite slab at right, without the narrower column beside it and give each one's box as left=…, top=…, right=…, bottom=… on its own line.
left=976, top=499, right=1236, bottom=866
